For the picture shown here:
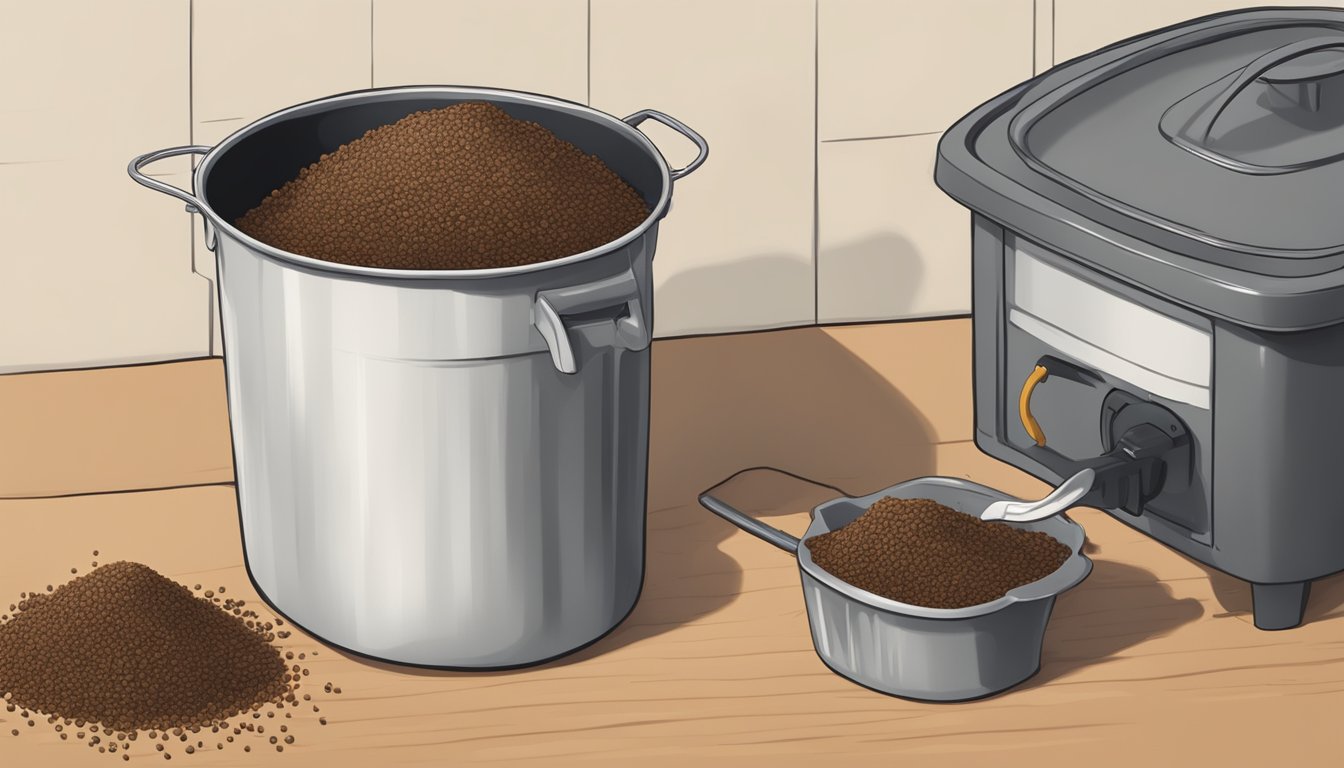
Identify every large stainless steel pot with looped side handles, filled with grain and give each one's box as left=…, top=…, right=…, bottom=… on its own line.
left=129, top=86, right=708, bottom=668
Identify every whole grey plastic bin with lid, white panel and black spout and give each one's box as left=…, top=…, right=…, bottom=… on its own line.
left=935, top=8, right=1344, bottom=629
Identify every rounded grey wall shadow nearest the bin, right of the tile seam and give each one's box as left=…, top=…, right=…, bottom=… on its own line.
left=817, top=233, right=925, bottom=323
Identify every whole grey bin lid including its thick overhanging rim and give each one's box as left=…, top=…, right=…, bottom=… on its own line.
left=938, top=8, right=1344, bottom=327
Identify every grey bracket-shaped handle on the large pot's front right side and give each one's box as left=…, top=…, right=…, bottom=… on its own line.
left=532, top=269, right=649, bottom=374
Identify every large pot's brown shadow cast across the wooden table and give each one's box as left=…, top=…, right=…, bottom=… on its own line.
left=334, top=327, right=946, bottom=677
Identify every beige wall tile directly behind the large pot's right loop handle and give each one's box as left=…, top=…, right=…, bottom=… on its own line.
left=590, top=0, right=816, bottom=336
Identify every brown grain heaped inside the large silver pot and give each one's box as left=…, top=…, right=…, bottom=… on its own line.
left=235, top=102, right=649, bottom=269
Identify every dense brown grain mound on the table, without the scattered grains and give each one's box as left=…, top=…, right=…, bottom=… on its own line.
left=0, top=562, right=286, bottom=732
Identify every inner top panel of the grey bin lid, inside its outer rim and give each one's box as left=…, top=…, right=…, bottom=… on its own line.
left=1008, top=9, right=1344, bottom=267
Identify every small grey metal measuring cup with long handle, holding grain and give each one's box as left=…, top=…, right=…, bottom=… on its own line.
left=700, top=477, right=1091, bottom=701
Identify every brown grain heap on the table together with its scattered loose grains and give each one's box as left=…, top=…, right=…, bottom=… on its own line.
left=0, top=553, right=339, bottom=760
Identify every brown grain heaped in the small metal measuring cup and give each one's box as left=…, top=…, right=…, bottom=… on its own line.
left=806, top=496, right=1071, bottom=608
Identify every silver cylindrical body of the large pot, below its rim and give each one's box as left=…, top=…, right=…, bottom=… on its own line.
left=219, top=229, right=656, bottom=667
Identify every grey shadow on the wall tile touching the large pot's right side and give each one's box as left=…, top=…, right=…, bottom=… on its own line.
left=653, top=253, right=813, bottom=336
